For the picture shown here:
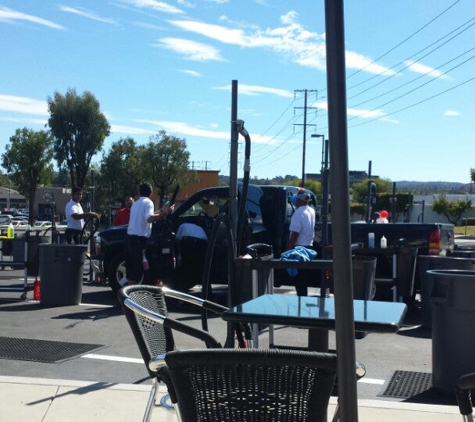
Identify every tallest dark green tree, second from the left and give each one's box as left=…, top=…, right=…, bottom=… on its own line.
left=48, top=89, right=110, bottom=188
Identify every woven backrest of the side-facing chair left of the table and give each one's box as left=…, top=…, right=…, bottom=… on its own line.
left=118, top=285, right=175, bottom=377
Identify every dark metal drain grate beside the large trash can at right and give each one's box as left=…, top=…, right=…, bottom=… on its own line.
left=381, top=371, right=432, bottom=398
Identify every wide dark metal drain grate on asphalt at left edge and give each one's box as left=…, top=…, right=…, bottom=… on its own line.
left=0, top=337, right=104, bottom=363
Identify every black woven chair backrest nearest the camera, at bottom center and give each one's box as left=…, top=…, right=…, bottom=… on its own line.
left=165, top=349, right=337, bottom=422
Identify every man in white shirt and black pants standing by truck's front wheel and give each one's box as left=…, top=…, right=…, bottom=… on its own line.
left=125, top=183, right=173, bottom=285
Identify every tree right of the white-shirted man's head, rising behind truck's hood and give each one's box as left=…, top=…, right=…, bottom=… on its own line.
left=140, top=130, right=190, bottom=205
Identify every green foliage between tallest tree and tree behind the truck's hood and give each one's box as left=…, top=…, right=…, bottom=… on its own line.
left=100, top=138, right=147, bottom=203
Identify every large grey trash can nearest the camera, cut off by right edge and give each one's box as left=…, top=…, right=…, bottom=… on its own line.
left=428, top=270, right=475, bottom=393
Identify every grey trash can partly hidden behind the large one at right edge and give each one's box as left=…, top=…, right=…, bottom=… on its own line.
left=417, top=255, right=475, bottom=329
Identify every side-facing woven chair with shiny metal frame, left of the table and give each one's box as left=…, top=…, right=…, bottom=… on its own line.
left=119, top=285, right=221, bottom=422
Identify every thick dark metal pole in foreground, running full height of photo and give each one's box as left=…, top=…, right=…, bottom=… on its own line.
left=325, top=0, right=358, bottom=422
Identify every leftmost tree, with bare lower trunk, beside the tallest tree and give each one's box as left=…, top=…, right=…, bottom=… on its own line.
left=2, top=128, right=54, bottom=223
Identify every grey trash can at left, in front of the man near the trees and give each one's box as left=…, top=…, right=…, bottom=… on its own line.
left=39, top=244, right=87, bottom=305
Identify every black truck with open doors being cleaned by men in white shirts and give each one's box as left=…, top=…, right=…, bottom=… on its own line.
left=92, top=184, right=317, bottom=291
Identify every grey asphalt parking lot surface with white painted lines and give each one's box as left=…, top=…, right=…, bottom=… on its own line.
left=0, top=237, right=475, bottom=404
